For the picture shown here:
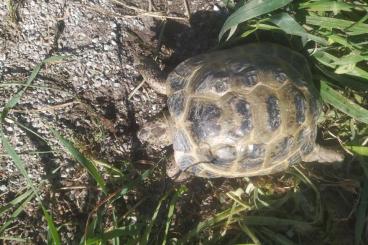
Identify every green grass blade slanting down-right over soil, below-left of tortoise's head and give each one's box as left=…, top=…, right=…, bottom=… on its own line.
left=51, top=129, right=107, bottom=193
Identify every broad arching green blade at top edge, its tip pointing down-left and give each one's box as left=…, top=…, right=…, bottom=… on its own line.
left=219, top=0, right=292, bottom=40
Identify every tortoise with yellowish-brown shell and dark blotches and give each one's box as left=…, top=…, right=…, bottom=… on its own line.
left=138, top=43, right=343, bottom=180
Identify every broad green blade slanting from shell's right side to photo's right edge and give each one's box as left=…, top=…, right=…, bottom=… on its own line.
left=320, top=81, right=368, bottom=123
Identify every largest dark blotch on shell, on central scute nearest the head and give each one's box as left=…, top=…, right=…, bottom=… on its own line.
left=188, top=101, right=221, bottom=141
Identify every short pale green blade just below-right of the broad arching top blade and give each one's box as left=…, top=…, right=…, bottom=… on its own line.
left=270, top=13, right=328, bottom=45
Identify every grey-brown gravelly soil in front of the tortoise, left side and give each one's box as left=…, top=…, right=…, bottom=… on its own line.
left=0, top=0, right=230, bottom=243
